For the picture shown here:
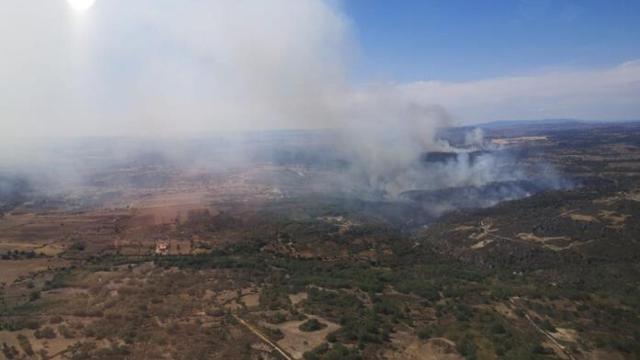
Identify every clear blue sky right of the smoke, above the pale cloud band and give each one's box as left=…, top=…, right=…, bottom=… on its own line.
left=343, top=0, right=640, bottom=82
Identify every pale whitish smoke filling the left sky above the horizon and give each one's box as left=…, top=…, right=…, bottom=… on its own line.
left=0, top=0, right=350, bottom=136
